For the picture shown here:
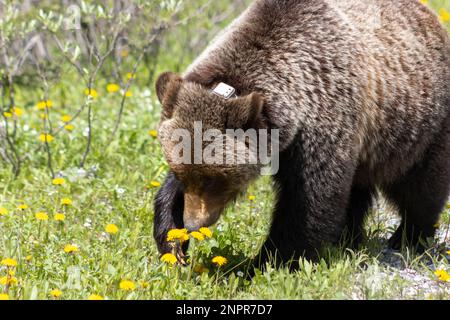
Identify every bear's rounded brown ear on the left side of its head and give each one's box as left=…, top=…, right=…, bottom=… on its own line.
left=156, top=72, right=183, bottom=118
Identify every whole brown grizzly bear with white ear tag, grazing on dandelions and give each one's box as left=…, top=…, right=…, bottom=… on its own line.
left=154, top=0, right=450, bottom=268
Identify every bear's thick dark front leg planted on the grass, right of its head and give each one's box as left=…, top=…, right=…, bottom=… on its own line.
left=254, top=137, right=355, bottom=270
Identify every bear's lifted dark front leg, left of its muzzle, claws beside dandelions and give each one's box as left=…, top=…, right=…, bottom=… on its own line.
left=153, top=172, right=188, bottom=258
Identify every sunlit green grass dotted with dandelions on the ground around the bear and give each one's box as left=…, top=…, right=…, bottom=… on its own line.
left=0, top=1, right=450, bottom=299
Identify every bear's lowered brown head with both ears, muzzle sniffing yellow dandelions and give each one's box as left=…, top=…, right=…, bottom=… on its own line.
left=156, top=72, right=264, bottom=231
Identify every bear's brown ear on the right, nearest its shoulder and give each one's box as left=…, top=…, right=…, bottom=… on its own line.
left=227, top=92, right=264, bottom=129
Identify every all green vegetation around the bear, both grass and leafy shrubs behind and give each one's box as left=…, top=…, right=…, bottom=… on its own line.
left=0, top=0, right=450, bottom=299
